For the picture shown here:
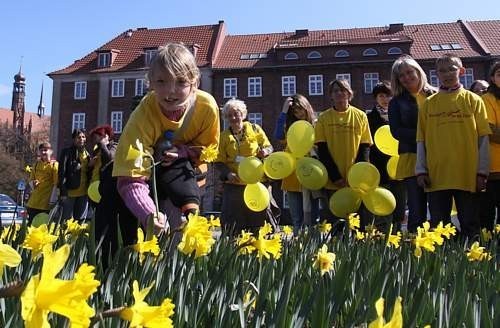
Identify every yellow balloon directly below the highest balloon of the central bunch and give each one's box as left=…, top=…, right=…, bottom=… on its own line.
left=295, top=157, right=328, bottom=190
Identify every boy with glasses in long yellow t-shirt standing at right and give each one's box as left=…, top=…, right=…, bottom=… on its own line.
left=415, top=54, right=491, bottom=237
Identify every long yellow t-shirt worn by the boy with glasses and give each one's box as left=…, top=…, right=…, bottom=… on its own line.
left=417, top=88, right=491, bottom=192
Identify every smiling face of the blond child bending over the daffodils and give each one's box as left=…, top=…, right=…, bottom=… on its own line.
left=151, top=71, right=193, bottom=112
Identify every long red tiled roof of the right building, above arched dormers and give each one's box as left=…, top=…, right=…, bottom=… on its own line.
left=213, top=22, right=494, bottom=69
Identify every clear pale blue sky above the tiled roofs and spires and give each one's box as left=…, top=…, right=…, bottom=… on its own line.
left=0, top=0, right=500, bottom=114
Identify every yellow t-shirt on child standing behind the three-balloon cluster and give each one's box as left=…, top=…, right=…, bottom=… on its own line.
left=314, top=105, right=373, bottom=190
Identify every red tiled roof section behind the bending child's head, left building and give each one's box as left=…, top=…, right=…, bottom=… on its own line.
left=49, top=21, right=223, bottom=75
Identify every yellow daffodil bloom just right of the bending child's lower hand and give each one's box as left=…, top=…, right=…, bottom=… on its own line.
left=177, top=214, right=215, bottom=258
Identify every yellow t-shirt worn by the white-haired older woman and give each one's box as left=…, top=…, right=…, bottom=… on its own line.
left=216, top=122, right=271, bottom=181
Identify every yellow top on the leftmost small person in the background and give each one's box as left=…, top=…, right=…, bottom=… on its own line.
left=26, top=161, right=58, bottom=210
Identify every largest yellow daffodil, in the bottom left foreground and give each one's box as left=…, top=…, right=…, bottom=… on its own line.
left=21, top=245, right=100, bottom=328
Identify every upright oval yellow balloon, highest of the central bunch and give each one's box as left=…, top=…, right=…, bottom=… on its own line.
left=286, top=120, right=314, bottom=158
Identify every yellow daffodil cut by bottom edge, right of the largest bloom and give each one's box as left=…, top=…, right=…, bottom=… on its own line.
left=120, top=280, right=175, bottom=328
